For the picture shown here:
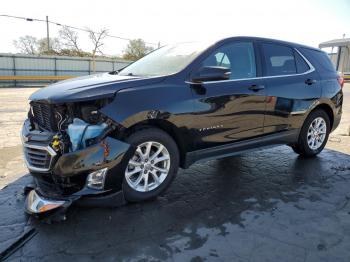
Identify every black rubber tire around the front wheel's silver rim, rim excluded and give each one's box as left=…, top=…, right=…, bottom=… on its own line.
left=123, top=128, right=179, bottom=202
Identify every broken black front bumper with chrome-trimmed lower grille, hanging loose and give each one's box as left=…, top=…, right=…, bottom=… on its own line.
left=22, top=118, right=133, bottom=214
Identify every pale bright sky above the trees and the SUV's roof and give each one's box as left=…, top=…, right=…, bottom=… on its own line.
left=0, top=0, right=350, bottom=55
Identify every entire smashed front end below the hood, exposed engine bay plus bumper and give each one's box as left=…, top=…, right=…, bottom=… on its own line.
left=22, top=99, right=132, bottom=215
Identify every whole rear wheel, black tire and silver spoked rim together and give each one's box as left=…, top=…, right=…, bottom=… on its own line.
left=292, top=109, right=330, bottom=157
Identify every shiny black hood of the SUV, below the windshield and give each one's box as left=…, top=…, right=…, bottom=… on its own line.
left=29, top=73, right=164, bottom=104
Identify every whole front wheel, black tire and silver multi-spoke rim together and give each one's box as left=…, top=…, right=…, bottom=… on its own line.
left=123, top=128, right=179, bottom=202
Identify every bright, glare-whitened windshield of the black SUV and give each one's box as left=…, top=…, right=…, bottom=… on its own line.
left=119, top=43, right=208, bottom=76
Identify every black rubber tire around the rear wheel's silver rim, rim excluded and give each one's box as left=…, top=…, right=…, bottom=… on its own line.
left=298, top=110, right=330, bottom=156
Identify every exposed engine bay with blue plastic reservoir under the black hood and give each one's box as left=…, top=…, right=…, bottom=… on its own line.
left=28, top=99, right=117, bottom=154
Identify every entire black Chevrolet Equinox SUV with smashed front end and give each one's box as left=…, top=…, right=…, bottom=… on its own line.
left=22, top=37, right=343, bottom=213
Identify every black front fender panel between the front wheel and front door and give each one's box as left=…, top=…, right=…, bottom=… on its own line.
left=100, top=80, right=195, bottom=154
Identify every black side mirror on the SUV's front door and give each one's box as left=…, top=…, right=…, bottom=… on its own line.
left=192, top=66, right=231, bottom=82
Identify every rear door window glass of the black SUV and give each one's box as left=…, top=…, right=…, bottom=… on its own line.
left=262, top=43, right=297, bottom=76
